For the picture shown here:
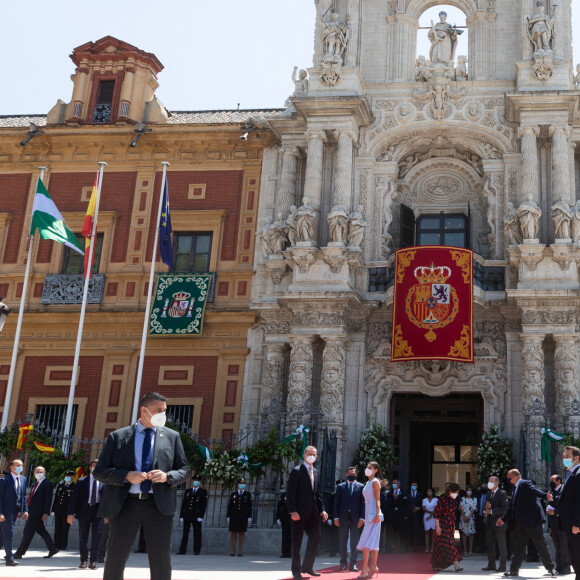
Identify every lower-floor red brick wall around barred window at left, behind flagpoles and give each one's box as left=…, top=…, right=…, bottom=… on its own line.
left=16, top=356, right=106, bottom=437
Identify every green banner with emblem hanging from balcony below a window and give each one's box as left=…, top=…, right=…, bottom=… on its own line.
left=149, top=274, right=212, bottom=336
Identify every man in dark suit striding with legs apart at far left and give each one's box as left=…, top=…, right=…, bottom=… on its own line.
left=14, top=465, right=58, bottom=559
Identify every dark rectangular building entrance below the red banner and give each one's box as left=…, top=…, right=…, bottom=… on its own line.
left=391, top=394, right=483, bottom=492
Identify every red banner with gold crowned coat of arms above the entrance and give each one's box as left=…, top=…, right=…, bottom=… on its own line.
left=391, top=246, right=473, bottom=362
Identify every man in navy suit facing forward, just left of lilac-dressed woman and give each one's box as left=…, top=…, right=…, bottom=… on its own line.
left=333, top=467, right=365, bottom=572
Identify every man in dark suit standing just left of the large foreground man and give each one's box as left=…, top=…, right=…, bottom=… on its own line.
left=67, top=459, right=103, bottom=570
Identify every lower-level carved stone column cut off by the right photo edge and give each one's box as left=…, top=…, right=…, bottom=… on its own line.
left=553, top=333, right=580, bottom=427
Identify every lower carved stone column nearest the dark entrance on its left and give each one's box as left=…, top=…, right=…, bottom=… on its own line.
left=320, top=336, right=346, bottom=466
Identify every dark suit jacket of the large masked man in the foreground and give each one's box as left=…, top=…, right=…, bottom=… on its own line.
left=93, top=425, right=189, bottom=519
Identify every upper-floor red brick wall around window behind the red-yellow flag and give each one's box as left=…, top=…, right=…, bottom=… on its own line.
left=48, top=170, right=137, bottom=262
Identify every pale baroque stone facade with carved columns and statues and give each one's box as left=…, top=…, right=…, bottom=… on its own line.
left=242, top=0, right=580, bottom=485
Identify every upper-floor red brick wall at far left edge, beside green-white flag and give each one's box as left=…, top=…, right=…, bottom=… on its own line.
left=0, top=173, right=32, bottom=264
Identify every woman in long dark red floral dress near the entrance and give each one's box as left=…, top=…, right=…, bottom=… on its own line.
left=431, top=483, right=463, bottom=572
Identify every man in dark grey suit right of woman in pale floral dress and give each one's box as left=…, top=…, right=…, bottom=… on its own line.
left=482, top=475, right=509, bottom=572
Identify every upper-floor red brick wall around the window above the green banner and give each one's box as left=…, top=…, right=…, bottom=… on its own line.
left=146, top=171, right=244, bottom=261
